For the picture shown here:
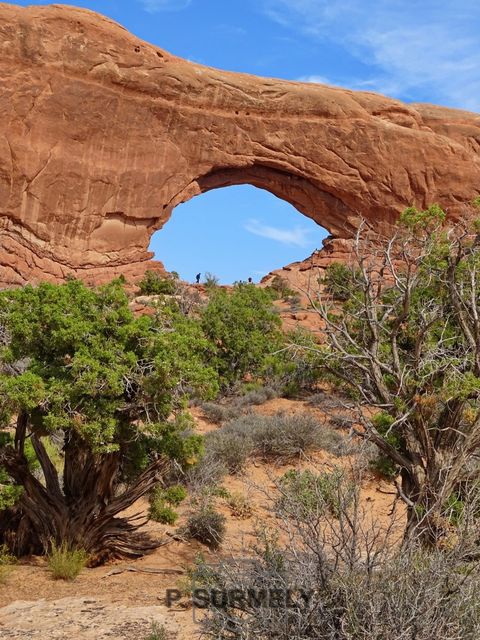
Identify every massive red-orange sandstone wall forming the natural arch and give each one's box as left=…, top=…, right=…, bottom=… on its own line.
left=0, top=4, right=480, bottom=286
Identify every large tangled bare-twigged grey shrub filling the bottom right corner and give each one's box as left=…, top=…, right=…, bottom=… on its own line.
left=203, top=460, right=480, bottom=640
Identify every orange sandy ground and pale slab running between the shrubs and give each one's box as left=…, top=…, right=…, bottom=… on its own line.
left=0, top=399, right=404, bottom=640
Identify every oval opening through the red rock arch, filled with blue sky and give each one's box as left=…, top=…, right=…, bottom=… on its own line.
left=149, top=185, right=328, bottom=284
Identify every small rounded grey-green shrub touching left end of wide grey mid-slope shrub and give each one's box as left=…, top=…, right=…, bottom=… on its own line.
left=205, top=422, right=254, bottom=473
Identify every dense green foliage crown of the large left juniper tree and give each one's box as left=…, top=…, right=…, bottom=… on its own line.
left=0, top=280, right=217, bottom=453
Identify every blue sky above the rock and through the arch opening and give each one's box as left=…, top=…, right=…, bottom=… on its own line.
left=13, top=0, right=480, bottom=282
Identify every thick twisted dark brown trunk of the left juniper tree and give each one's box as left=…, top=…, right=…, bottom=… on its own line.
left=0, top=418, right=168, bottom=566
